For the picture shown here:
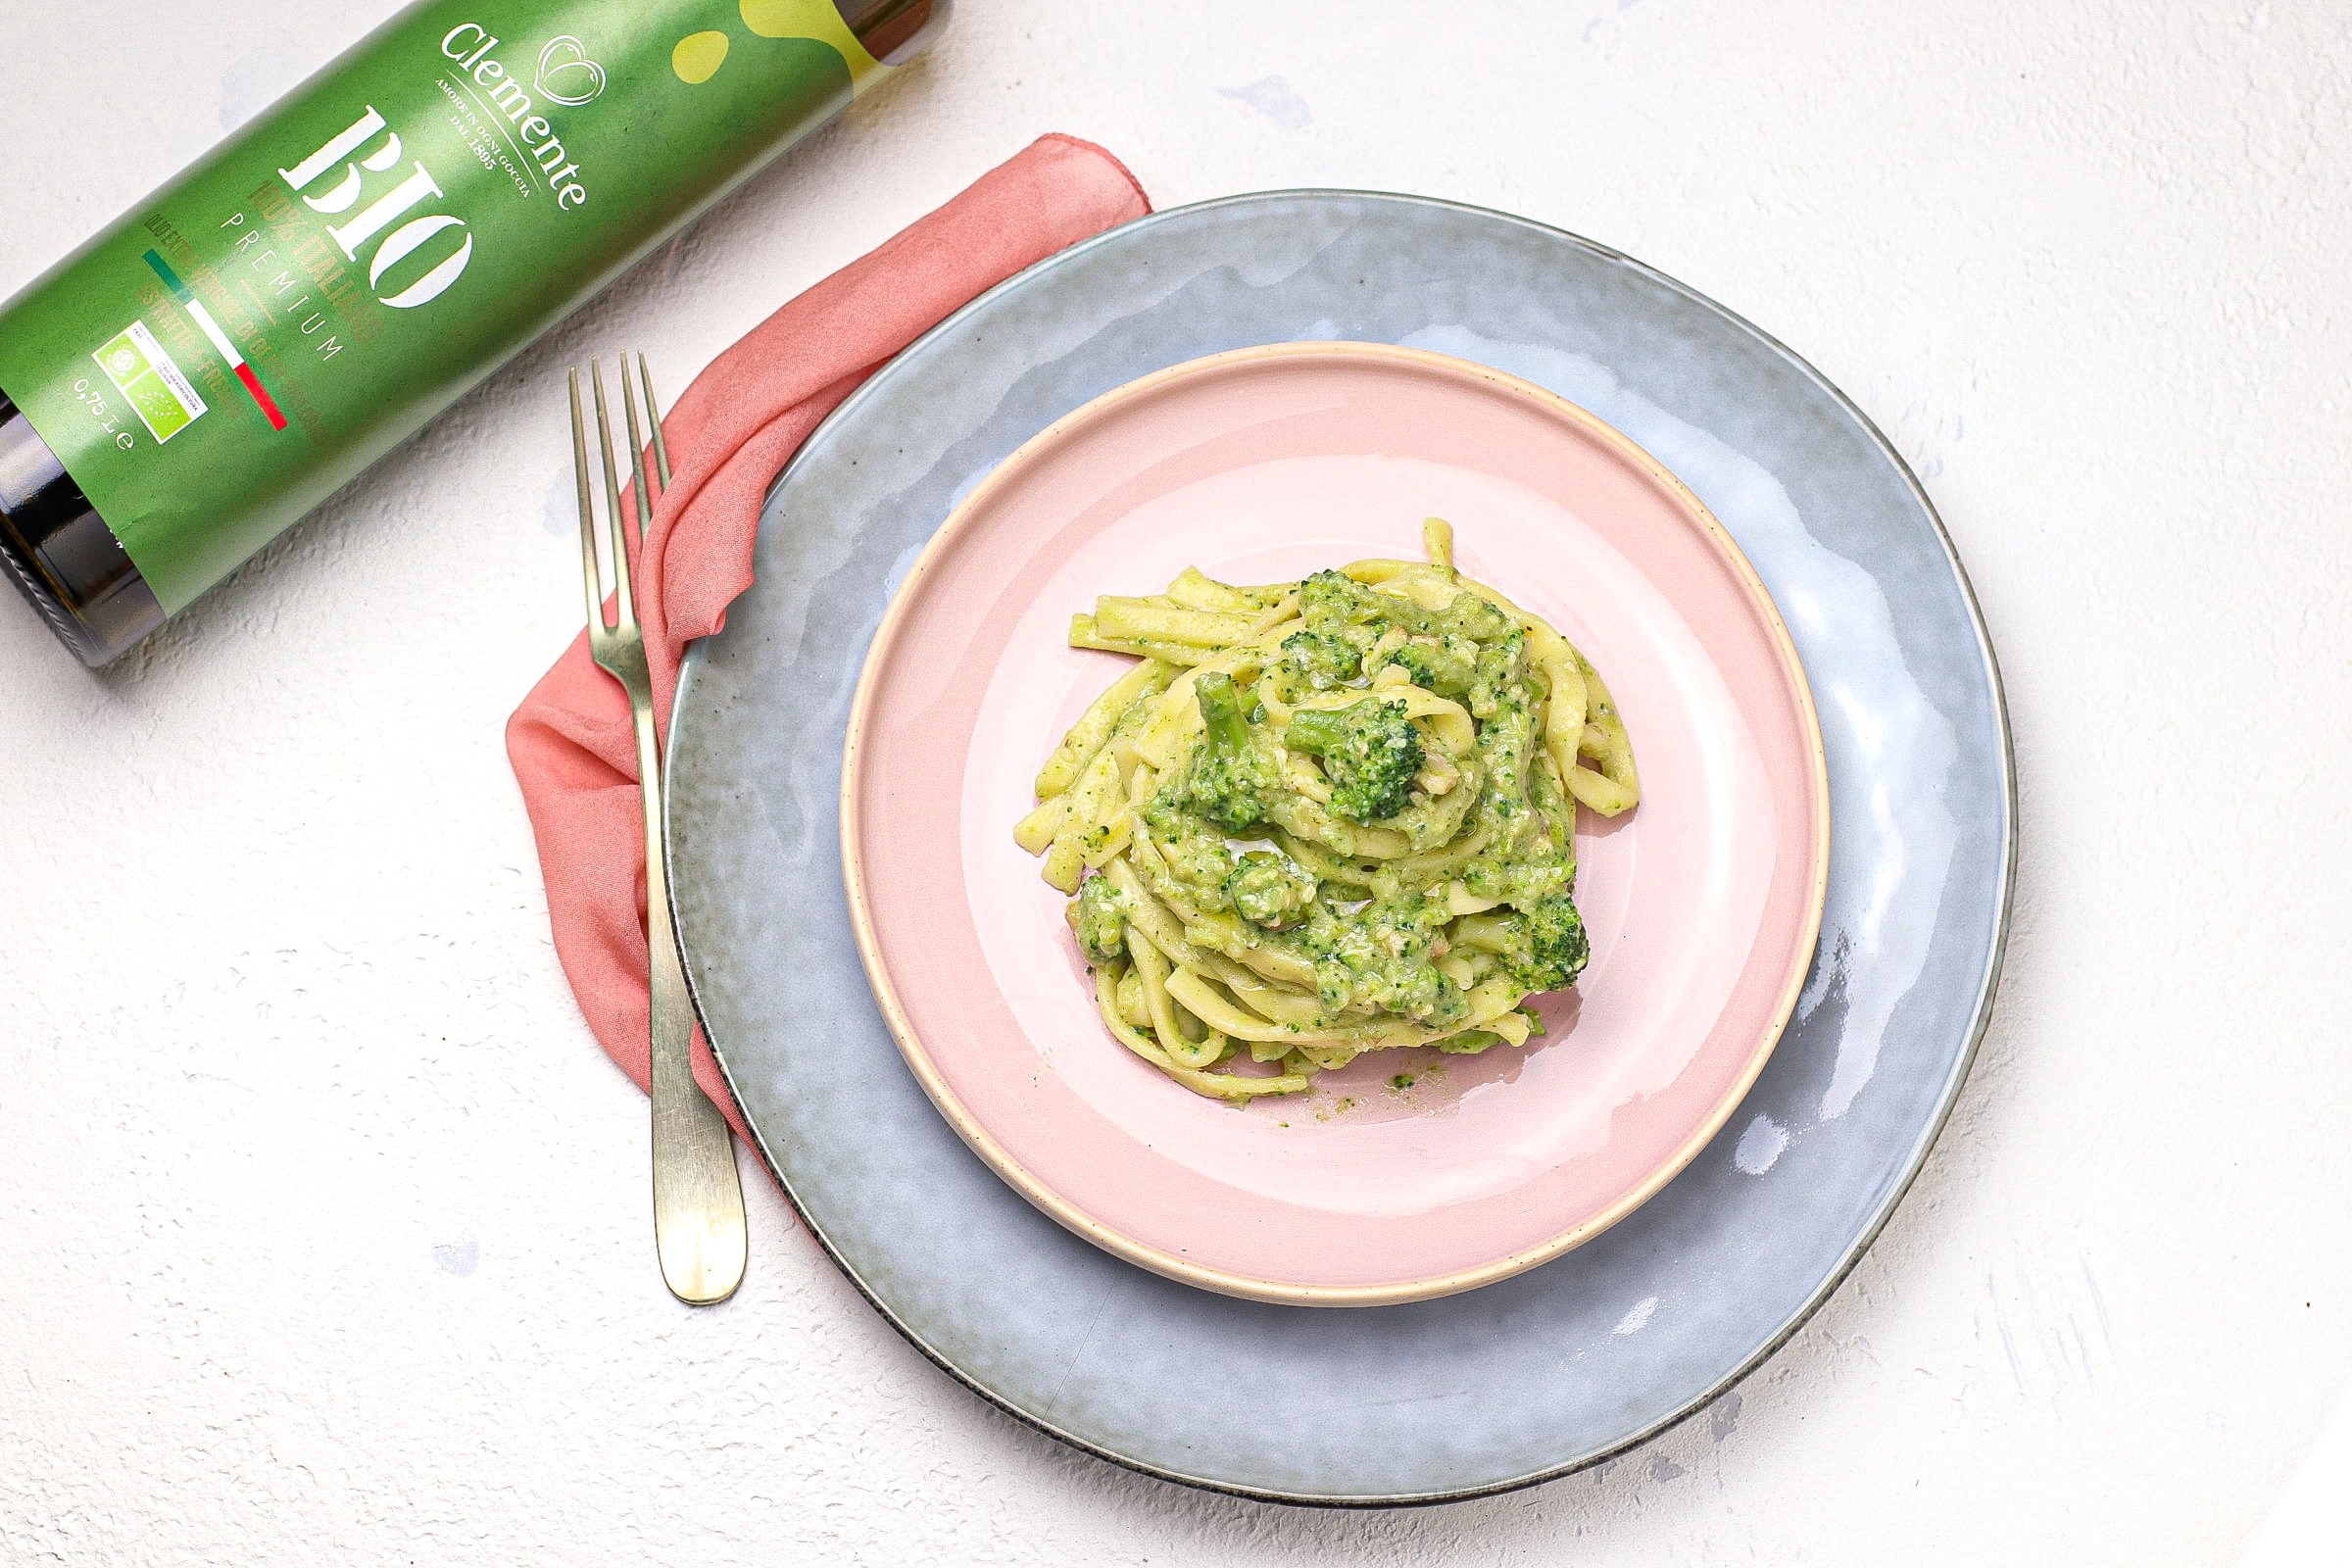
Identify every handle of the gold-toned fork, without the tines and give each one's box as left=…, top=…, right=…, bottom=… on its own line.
left=630, top=703, right=751, bottom=1307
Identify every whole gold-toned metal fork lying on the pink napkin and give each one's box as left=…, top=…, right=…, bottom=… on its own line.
left=571, top=355, right=751, bottom=1307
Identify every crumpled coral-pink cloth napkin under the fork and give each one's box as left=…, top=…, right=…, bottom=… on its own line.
left=506, top=136, right=1151, bottom=1136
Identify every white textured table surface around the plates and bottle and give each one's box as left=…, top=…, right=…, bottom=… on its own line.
left=0, top=0, right=2352, bottom=1568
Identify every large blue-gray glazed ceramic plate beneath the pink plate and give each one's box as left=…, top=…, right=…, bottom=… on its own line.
left=668, top=190, right=2016, bottom=1504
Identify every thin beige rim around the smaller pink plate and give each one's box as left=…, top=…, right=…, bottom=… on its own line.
left=840, top=338, right=1830, bottom=1307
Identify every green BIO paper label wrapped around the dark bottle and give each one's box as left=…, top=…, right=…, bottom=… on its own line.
left=0, top=0, right=884, bottom=613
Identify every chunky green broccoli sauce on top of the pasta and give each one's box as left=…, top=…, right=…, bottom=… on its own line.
left=1091, top=557, right=1588, bottom=1055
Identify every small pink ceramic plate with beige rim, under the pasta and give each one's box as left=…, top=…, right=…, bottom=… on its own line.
left=842, top=343, right=1828, bottom=1304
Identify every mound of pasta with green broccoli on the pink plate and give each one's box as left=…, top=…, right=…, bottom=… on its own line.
left=1013, top=517, right=1640, bottom=1102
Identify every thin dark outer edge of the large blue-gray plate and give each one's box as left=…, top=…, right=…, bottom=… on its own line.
left=661, top=186, right=2018, bottom=1509
